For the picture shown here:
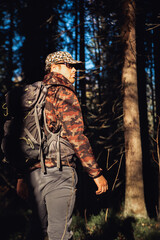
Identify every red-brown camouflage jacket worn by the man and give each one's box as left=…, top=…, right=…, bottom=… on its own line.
left=37, top=72, right=102, bottom=178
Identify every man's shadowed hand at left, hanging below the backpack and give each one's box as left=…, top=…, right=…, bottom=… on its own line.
left=16, top=178, right=28, bottom=200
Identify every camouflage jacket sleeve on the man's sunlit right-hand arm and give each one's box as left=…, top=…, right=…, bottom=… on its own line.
left=56, top=87, right=102, bottom=178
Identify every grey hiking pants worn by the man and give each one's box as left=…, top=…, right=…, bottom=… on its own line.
left=29, top=166, right=77, bottom=240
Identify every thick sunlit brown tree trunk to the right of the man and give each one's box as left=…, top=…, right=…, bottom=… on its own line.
left=122, top=0, right=147, bottom=217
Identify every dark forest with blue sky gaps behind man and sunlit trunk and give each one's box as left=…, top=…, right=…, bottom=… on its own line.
left=0, top=0, right=160, bottom=240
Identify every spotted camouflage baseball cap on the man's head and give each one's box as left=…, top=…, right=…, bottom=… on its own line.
left=45, top=51, right=82, bottom=71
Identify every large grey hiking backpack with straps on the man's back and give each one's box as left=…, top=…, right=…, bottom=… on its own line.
left=1, top=81, right=74, bottom=174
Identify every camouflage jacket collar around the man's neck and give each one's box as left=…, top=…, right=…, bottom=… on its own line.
left=43, top=72, right=75, bottom=92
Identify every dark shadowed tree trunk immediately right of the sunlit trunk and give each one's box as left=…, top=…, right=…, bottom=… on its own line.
left=136, top=0, right=155, bottom=215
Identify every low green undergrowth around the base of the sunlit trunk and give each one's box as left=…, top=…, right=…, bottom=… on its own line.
left=72, top=210, right=160, bottom=240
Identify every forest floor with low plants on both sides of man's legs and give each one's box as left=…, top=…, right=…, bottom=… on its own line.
left=0, top=194, right=160, bottom=240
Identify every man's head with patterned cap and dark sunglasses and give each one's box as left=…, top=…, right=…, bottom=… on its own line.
left=45, top=51, right=82, bottom=83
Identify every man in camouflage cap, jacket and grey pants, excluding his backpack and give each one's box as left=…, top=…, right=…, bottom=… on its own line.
left=17, top=51, right=108, bottom=240
